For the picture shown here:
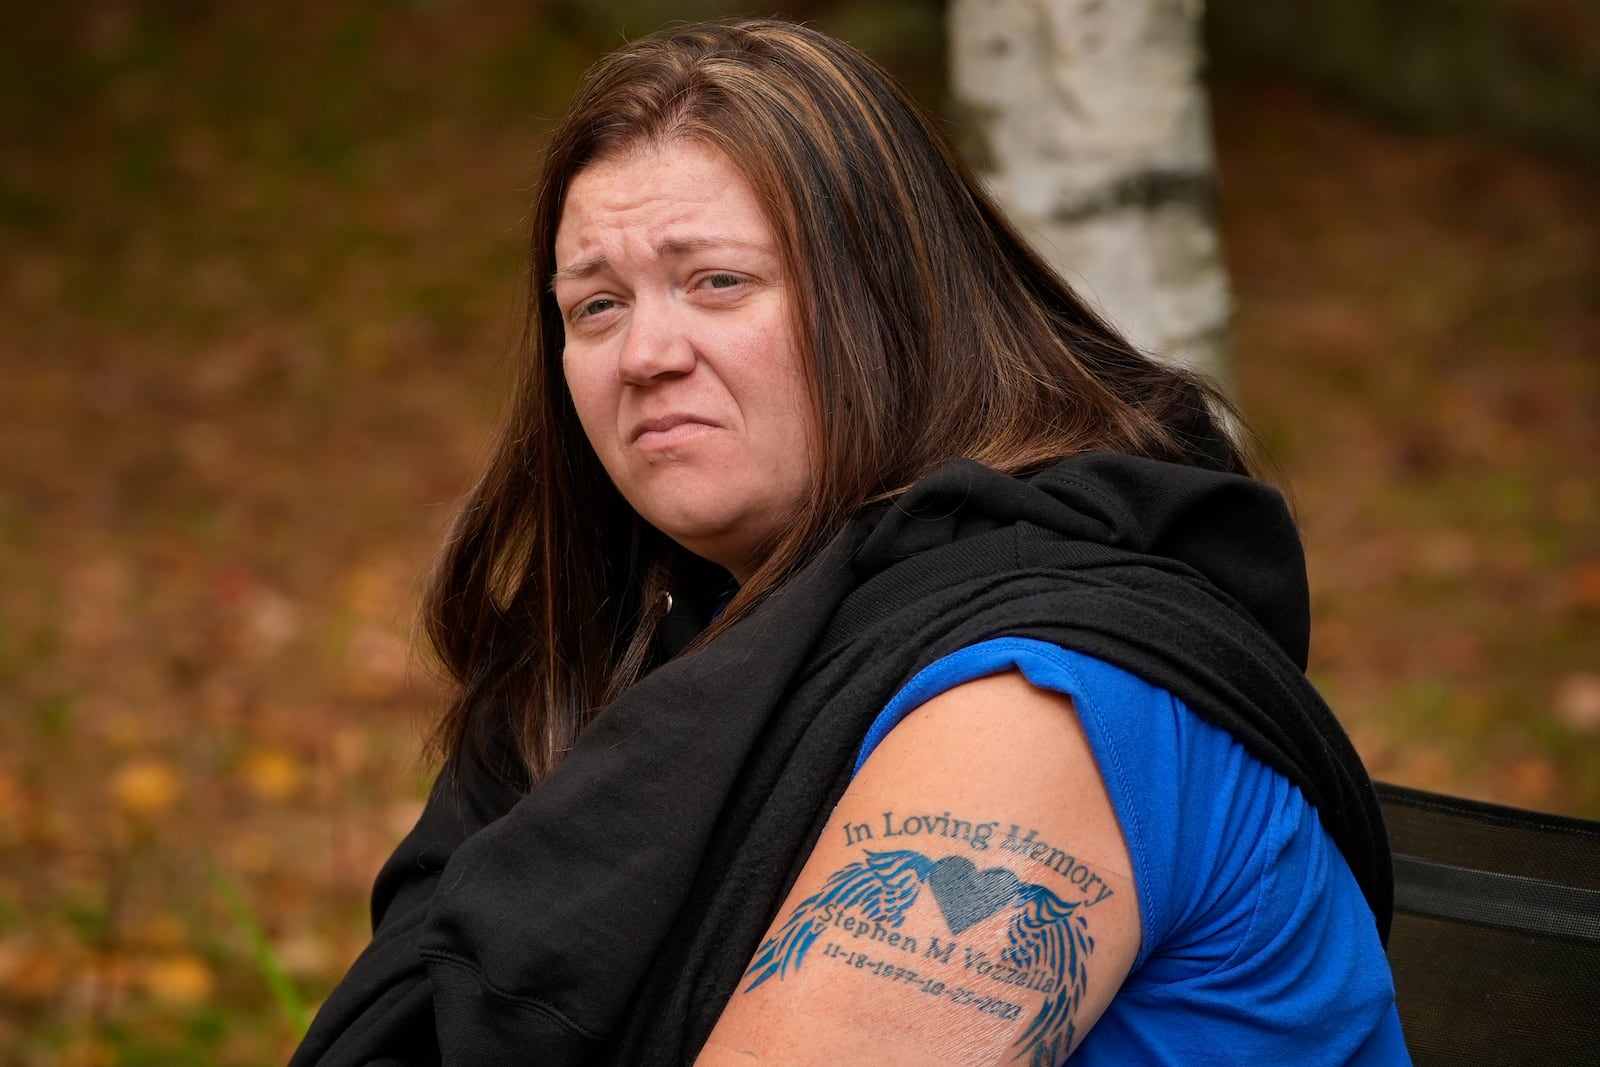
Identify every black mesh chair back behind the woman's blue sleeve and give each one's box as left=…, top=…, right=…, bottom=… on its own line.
left=1378, top=784, right=1600, bottom=1067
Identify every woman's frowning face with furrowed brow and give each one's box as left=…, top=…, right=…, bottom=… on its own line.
left=554, top=139, right=818, bottom=581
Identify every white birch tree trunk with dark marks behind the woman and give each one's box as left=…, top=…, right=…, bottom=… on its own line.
left=950, top=0, right=1232, bottom=389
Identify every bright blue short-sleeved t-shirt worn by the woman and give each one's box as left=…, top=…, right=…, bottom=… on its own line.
left=856, top=637, right=1411, bottom=1067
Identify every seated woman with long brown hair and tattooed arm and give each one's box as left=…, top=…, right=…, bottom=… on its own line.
left=296, top=21, right=1406, bottom=1064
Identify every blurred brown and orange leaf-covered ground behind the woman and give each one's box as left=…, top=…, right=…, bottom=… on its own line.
left=0, top=0, right=1600, bottom=1067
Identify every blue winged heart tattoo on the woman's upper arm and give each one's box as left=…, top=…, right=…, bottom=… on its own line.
left=744, top=849, right=1094, bottom=1067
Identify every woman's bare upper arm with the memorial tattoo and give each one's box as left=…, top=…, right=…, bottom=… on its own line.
left=699, top=672, right=1139, bottom=1067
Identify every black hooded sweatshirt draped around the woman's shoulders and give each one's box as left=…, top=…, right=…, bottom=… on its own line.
left=293, top=453, right=1392, bottom=1067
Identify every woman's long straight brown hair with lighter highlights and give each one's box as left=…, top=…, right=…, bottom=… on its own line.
left=427, top=19, right=1248, bottom=784
